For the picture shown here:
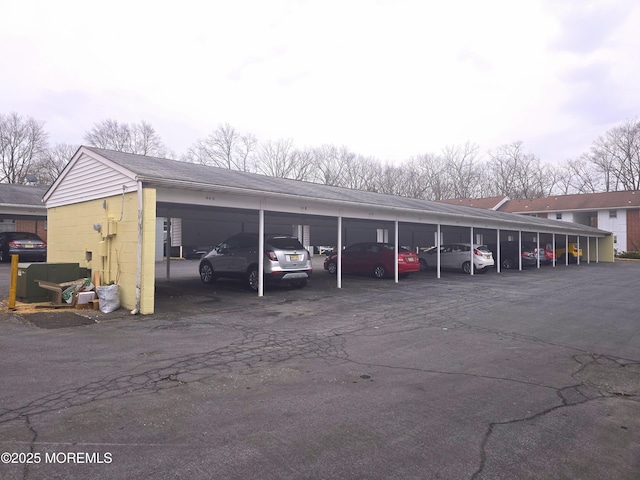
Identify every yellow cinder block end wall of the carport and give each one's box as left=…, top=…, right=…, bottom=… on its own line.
left=47, top=188, right=156, bottom=314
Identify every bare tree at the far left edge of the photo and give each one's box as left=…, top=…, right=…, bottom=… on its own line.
left=0, top=113, right=48, bottom=183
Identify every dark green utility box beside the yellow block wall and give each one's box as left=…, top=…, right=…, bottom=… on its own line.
left=16, top=262, right=90, bottom=303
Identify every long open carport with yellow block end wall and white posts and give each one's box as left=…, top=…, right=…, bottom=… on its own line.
left=44, top=147, right=613, bottom=314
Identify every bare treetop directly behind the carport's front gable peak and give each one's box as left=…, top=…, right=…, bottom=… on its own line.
left=84, top=119, right=170, bottom=157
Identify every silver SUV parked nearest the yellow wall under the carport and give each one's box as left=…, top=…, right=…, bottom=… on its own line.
left=200, top=233, right=312, bottom=290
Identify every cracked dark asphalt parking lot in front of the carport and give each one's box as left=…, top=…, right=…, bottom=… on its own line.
left=0, top=261, right=640, bottom=480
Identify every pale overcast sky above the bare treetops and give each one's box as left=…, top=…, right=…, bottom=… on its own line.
left=0, top=0, right=640, bottom=163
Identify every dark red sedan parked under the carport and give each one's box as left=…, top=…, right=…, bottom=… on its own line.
left=324, top=242, right=420, bottom=278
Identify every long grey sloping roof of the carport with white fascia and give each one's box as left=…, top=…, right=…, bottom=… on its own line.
left=44, top=147, right=610, bottom=237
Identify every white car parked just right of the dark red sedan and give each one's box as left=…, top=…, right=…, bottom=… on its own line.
left=419, top=243, right=494, bottom=273
